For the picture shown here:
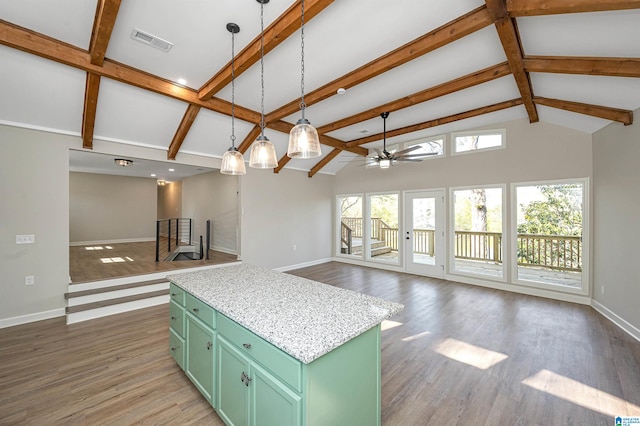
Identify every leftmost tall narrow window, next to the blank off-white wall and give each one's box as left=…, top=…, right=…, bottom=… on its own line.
left=337, top=195, right=364, bottom=258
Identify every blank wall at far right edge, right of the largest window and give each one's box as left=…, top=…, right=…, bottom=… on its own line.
left=593, top=110, right=640, bottom=339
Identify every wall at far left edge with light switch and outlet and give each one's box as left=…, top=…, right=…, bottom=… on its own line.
left=0, top=125, right=74, bottom=327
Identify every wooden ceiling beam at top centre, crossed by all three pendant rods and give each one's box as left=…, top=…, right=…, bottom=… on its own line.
left=198, top=0, right=334, bottom=100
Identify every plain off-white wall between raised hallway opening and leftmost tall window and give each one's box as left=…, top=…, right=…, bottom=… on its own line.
left=240, top=167, right=335, bottom=269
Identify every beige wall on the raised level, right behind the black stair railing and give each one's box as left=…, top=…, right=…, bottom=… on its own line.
left=182, top=170, right=239, bottom=254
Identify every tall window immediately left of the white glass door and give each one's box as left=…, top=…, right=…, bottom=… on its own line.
left=368, top=193, right=400, bottom=264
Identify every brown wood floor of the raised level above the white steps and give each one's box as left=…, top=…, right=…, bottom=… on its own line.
left=69, top=241, right=237, bottom=284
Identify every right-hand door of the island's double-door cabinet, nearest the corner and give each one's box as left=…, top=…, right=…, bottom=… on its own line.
left=251, top=364, right=302, bottom=426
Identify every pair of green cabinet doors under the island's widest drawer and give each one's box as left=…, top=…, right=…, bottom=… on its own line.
left=217, top=336, right=302, bottom=426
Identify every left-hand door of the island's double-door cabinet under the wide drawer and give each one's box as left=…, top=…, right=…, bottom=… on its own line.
left=217, top=336, right=251, bottom=426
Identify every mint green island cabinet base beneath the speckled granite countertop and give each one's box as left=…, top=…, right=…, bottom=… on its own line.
left=169, top=284, right=381, bottom=426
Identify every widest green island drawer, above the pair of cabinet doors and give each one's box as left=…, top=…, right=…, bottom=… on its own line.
left=218, top=315, right=302, bottom=392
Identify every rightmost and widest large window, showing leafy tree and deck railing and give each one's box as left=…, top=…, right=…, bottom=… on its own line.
left=514, top=180, right=587, bottom=290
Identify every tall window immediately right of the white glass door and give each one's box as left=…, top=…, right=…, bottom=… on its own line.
left=451, top=187, right=503, bottom=278
